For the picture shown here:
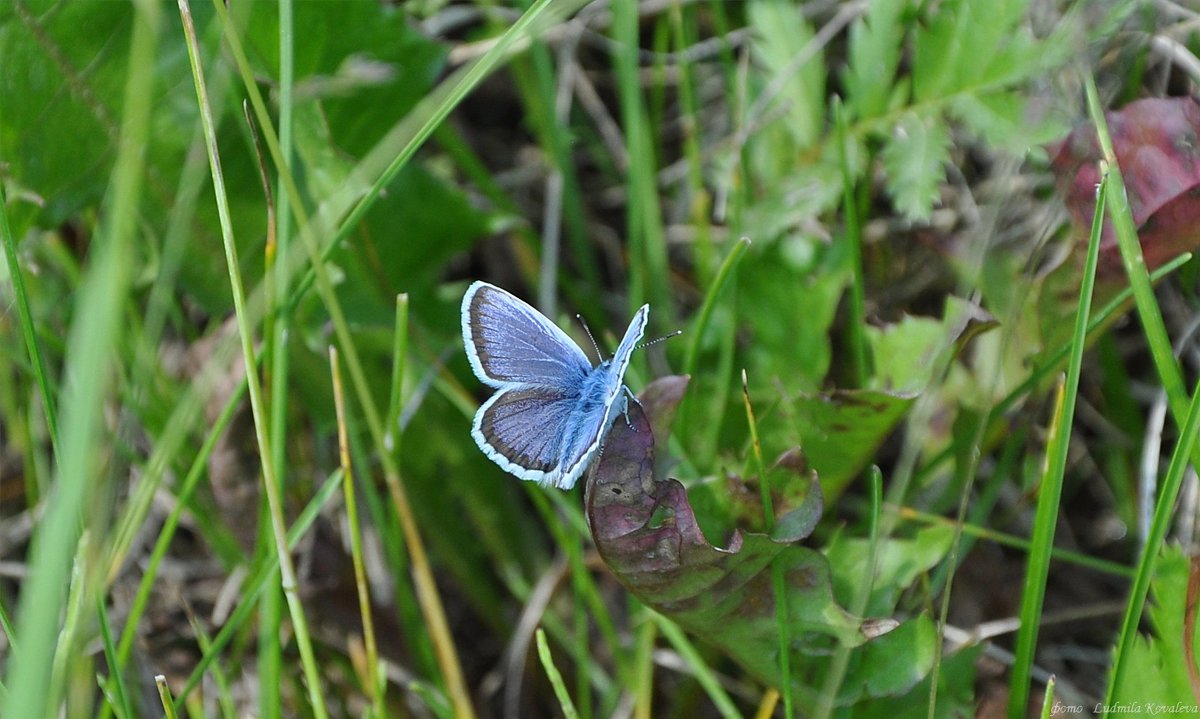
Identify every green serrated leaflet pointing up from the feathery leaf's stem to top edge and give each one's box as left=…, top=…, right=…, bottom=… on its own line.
left=846, top=0, right=912, bottom=119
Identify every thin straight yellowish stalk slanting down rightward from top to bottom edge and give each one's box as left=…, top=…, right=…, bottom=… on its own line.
left=179, top=0, right=328, bottom=719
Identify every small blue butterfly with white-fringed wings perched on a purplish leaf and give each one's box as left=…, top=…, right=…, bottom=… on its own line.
left=462, top=282, right=650, bottom=490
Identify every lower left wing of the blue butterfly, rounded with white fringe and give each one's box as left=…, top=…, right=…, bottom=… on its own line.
left=470, top=387, right=580, bottom=485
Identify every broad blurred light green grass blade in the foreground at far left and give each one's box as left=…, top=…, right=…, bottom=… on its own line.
left=0, top=0, right=162, bottom=717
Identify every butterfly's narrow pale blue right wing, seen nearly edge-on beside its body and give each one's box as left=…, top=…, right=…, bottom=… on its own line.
left=553, top=305, right=649, bottom=490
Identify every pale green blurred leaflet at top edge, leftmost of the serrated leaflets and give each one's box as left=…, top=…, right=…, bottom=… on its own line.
left=749, top=0, right=826, bottom=149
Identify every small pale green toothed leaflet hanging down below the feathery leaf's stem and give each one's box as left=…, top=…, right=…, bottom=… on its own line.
left=882, top=112, right=950, bottom=221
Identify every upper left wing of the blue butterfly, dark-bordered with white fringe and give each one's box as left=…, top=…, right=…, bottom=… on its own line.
left=462, top=282, right=592, bottom=390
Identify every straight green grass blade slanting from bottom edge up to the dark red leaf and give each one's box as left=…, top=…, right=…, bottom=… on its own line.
left=1008, top=171, right=1099, bottom=719
